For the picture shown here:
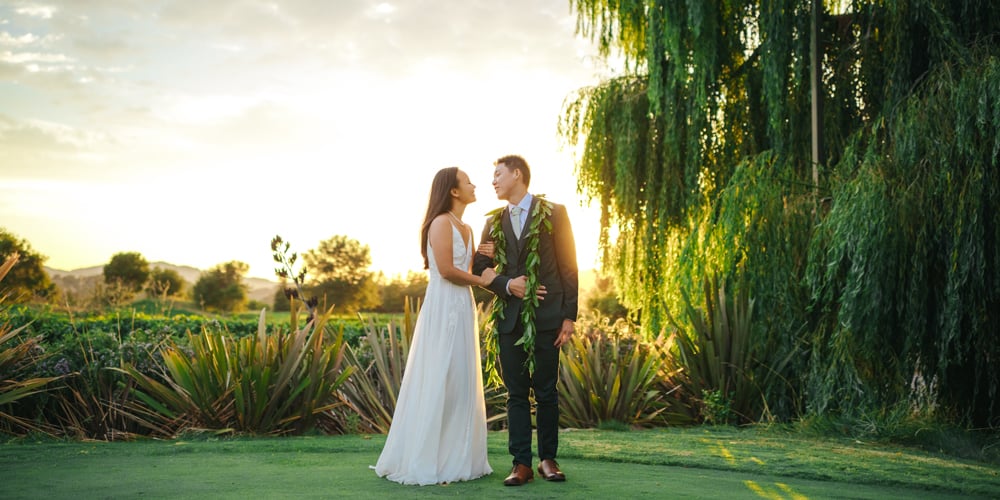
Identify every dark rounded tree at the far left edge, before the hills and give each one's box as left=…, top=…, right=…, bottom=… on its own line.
left=0, top=228, right=56, bottom=302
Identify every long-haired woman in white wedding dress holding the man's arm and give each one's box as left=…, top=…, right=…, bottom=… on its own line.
left=375, top=167, right=495, bottom=485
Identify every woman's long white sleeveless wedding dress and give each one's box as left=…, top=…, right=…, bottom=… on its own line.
left=375, top=225, right=493, bottom=485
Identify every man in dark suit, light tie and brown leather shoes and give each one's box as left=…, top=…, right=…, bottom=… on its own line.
left=473, top=155, right=577, bottom=486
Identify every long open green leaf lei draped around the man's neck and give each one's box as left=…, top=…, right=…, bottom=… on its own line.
left=485, top=196, right=552, bottom=381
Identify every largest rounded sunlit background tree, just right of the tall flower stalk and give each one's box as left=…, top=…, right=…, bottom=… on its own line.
left=303, top=235, right=380, bottom=314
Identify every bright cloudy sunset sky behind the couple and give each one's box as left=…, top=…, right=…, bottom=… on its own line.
left=0, top=0, right=608, bottom=279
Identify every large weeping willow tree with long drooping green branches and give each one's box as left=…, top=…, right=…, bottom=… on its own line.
left=560, top=0, right=1000, bottom=420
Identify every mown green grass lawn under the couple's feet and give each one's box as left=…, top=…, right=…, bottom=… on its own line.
left=0, top=427, right=1000, bottom=500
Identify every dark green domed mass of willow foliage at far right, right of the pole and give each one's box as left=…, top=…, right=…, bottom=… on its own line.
left=810, top=50, right=1000, bottom=422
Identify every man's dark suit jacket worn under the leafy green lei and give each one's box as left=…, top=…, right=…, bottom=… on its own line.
left=472, top=197, right=579, bottom=334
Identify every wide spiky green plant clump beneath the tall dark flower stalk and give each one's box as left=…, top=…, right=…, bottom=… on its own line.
left=125, top=300, right=352, bottom=435
